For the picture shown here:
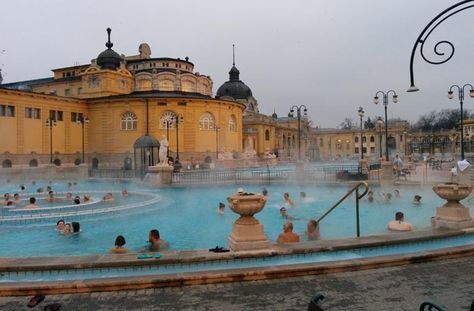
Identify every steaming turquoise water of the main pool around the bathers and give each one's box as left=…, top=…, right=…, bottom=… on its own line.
left=0, top=181, right=471, bottom=257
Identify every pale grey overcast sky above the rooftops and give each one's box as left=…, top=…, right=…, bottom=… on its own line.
left=0, top=0, right=474, bottom=127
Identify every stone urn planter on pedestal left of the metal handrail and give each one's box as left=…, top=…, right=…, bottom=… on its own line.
left=227, top=193, right=270, bottom=251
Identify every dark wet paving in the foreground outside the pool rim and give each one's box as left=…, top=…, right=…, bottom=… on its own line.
left=0, top=257, right=474, bottom=311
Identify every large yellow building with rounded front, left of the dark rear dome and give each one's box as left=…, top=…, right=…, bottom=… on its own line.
left=0, top=29, right=246, bottom=168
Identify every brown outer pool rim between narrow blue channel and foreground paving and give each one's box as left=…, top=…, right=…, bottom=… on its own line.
left=0, top=245, right=474, bottom=296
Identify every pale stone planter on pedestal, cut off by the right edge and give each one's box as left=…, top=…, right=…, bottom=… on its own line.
left=433, top=183, right=474, bottom=229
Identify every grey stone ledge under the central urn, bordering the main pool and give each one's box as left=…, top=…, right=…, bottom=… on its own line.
left=0, top=229, right=466, bottom=272
